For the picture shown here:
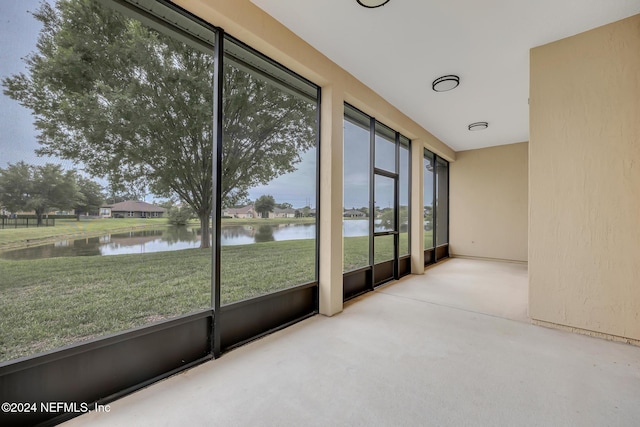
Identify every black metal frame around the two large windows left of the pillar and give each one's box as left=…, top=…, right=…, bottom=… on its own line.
left=0, top=0, right=321, bottom=425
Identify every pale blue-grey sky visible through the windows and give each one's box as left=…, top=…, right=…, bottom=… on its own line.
left=0, top=0, right=418, bottom=209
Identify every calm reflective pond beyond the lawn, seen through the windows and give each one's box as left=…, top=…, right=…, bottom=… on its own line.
left=0, top=219, right=380, bottom=261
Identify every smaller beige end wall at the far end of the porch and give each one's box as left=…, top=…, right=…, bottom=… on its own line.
left=449, top=142, right=528, bottom=262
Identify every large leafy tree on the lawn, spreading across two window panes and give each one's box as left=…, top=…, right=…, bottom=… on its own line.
left=2, top=0, right=315, bottom=247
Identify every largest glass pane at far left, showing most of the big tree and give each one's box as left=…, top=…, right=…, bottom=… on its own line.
left=0, top=1, right=213, bottom=360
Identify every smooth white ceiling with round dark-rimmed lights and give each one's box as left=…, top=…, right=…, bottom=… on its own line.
left=251, top=0, right=640, bottom=151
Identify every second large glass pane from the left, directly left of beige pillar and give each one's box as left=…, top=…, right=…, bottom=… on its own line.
left=220, top=39, right=318, bottom=305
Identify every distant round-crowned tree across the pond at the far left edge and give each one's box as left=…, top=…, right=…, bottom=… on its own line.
left=0, top=162, right=82, bottom=225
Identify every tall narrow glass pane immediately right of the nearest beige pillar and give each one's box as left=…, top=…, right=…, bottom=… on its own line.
left=342, top=106, right=371, bottom=272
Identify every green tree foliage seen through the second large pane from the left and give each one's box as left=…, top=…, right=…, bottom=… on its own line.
left=222, top=65, right=316, bottom=206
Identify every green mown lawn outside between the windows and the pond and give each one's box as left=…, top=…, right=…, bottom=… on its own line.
left=0, top=226, right=427, bottom=361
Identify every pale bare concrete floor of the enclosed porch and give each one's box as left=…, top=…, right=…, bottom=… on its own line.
left=65, top=259, right=640, bottom=426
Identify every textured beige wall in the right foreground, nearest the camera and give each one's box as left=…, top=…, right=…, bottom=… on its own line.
left=529, top=15, right=640, bottom=340
